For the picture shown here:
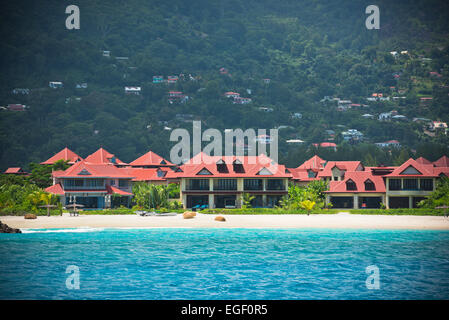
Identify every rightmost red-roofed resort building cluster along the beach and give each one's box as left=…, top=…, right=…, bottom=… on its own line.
left=288, top=156, right=449, bottom=209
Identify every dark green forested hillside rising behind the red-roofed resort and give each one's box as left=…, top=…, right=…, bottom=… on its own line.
left=0, top=0, right=449, bottom=170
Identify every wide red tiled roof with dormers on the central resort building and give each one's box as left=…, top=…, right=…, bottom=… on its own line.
left=170, top=152, right=292, bottom=178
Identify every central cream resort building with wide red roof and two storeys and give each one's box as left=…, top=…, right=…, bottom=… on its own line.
left=169, top=153, right=291, bottom=208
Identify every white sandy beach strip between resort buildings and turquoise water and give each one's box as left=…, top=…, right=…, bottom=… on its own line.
left=0, top=212, right=449, bottom=230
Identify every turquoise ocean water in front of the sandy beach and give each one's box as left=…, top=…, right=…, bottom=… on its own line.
left=0, top=229, right=449, bottom=299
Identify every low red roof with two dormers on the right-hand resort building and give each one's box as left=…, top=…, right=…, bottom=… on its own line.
left=326, top=171, right=386, bottom=193
